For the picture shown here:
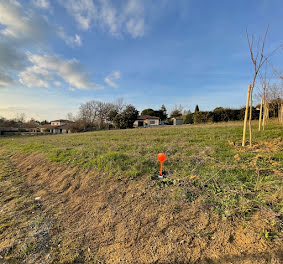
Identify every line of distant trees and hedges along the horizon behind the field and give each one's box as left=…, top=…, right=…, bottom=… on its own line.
left=0, top=97, right=283, bottom=132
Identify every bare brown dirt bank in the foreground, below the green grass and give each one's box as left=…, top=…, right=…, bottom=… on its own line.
left=0, top=150, right=283, bottom=263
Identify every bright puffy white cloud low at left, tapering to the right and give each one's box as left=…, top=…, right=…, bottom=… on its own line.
left=19, top=54, right=103, bottom=90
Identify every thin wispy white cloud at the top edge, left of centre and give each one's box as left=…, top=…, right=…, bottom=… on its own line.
left=59, top=0, right=145, bottom=38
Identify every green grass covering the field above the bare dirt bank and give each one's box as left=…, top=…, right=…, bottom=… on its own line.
left=0, top=122, right=283, bottom=217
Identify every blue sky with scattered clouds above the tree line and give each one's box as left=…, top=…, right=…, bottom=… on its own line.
left=0, top=0, right=283, bottom=120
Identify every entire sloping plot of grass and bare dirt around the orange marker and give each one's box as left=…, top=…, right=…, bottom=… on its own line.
left=0, top=122, right=283, bottom=263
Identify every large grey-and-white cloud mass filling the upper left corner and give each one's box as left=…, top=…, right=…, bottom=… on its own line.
left=0, top=0, right=96, bottom=89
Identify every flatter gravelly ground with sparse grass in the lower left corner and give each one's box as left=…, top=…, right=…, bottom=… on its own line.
left=0, top=152, right=58, bottom=263
